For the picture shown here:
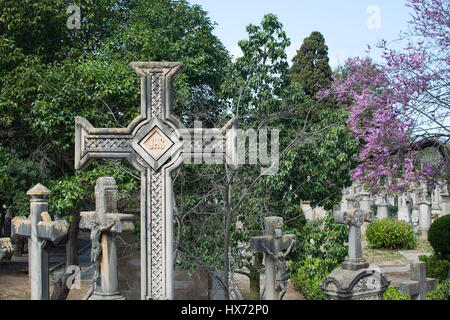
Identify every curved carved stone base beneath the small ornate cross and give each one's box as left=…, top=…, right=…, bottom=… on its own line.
left=320, top=268, right=390, bottom=300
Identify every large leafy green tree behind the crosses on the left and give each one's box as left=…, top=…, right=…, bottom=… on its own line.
left=0, top=0, right=229, bottom=299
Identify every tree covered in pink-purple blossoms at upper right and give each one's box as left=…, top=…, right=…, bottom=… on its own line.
left=321, top=0, right=450, bottom=192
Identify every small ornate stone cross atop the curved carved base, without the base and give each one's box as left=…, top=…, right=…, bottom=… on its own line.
left=334, top=195, right=374, bottom=270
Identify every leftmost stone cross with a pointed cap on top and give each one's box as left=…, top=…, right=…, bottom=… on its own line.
left=11, top=184, right=69, bottom=300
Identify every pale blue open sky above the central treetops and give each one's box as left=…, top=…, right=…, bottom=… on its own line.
left=188, top=0, right=411, bottom=68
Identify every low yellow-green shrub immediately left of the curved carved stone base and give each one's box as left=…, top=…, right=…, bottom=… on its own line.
left=291, top=258, right=337, bottom=300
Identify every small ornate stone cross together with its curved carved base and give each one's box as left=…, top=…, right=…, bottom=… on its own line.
left=320, top=195, right=390, bottom=300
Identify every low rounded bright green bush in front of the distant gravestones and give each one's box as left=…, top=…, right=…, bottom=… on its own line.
left=366, top=218, right=417, bottom=249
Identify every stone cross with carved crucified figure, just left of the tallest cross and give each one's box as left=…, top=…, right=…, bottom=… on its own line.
left=80, top=177, right=134, bottom=300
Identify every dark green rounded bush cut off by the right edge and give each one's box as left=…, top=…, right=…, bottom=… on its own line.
left=428, top=215, right=450, bottom=259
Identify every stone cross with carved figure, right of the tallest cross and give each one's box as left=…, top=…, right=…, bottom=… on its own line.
left=250, top=217, right=296, bottom=300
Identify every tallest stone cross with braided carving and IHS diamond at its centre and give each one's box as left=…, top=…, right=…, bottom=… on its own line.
left=75, top=62, right=237, bottom=300
